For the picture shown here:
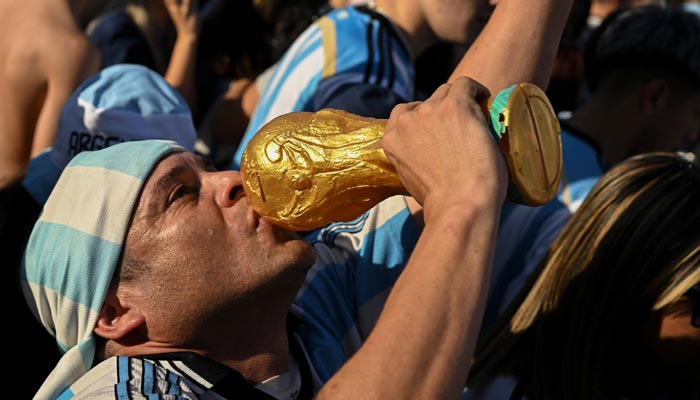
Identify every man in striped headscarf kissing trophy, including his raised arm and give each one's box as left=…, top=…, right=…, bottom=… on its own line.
left=22, top=78, right=508, bottom=399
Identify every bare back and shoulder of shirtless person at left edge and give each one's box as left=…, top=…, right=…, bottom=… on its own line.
left=0, top=0, right=100, bottom=167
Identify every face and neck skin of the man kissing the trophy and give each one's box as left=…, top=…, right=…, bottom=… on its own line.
left=106, top=153, right=314, bottom=381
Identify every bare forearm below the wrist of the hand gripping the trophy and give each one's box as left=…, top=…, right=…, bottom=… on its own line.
left=319, top=201, right=500, bottom=399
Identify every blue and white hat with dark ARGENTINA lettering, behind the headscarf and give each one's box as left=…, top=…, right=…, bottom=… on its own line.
left=22, top=64, right=197, bottom=205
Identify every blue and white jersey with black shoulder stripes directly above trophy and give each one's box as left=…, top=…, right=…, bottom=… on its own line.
left=230, top=6, right=415, bottom=170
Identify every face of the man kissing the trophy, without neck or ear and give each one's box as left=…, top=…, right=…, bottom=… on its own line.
left=125, top=153, right=314, bottom=330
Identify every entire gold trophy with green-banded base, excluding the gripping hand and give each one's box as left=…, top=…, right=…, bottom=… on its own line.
left=241, top=83, right=562, bottom=231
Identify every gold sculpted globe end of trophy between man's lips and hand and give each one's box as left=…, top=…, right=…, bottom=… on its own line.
left=241, top=109, right=405, bottom=230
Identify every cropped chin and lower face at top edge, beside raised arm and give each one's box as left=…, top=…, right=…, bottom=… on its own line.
left=421, top=0, right=497, bottom=44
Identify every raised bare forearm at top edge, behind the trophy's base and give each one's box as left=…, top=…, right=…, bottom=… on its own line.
left=449, top=0, right=572, bottom=93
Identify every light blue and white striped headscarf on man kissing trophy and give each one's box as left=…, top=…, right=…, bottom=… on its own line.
left=21, top=140, right=185, bottom=399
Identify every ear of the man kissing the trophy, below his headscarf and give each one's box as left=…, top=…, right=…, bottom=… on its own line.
left=95, top=294, right=146, bottom=340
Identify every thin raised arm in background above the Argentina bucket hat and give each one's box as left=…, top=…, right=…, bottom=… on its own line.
left=163, top=0, right=201, bottom=114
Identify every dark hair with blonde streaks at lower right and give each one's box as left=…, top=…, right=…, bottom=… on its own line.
left=468, top=153, right=700, bottom=399
